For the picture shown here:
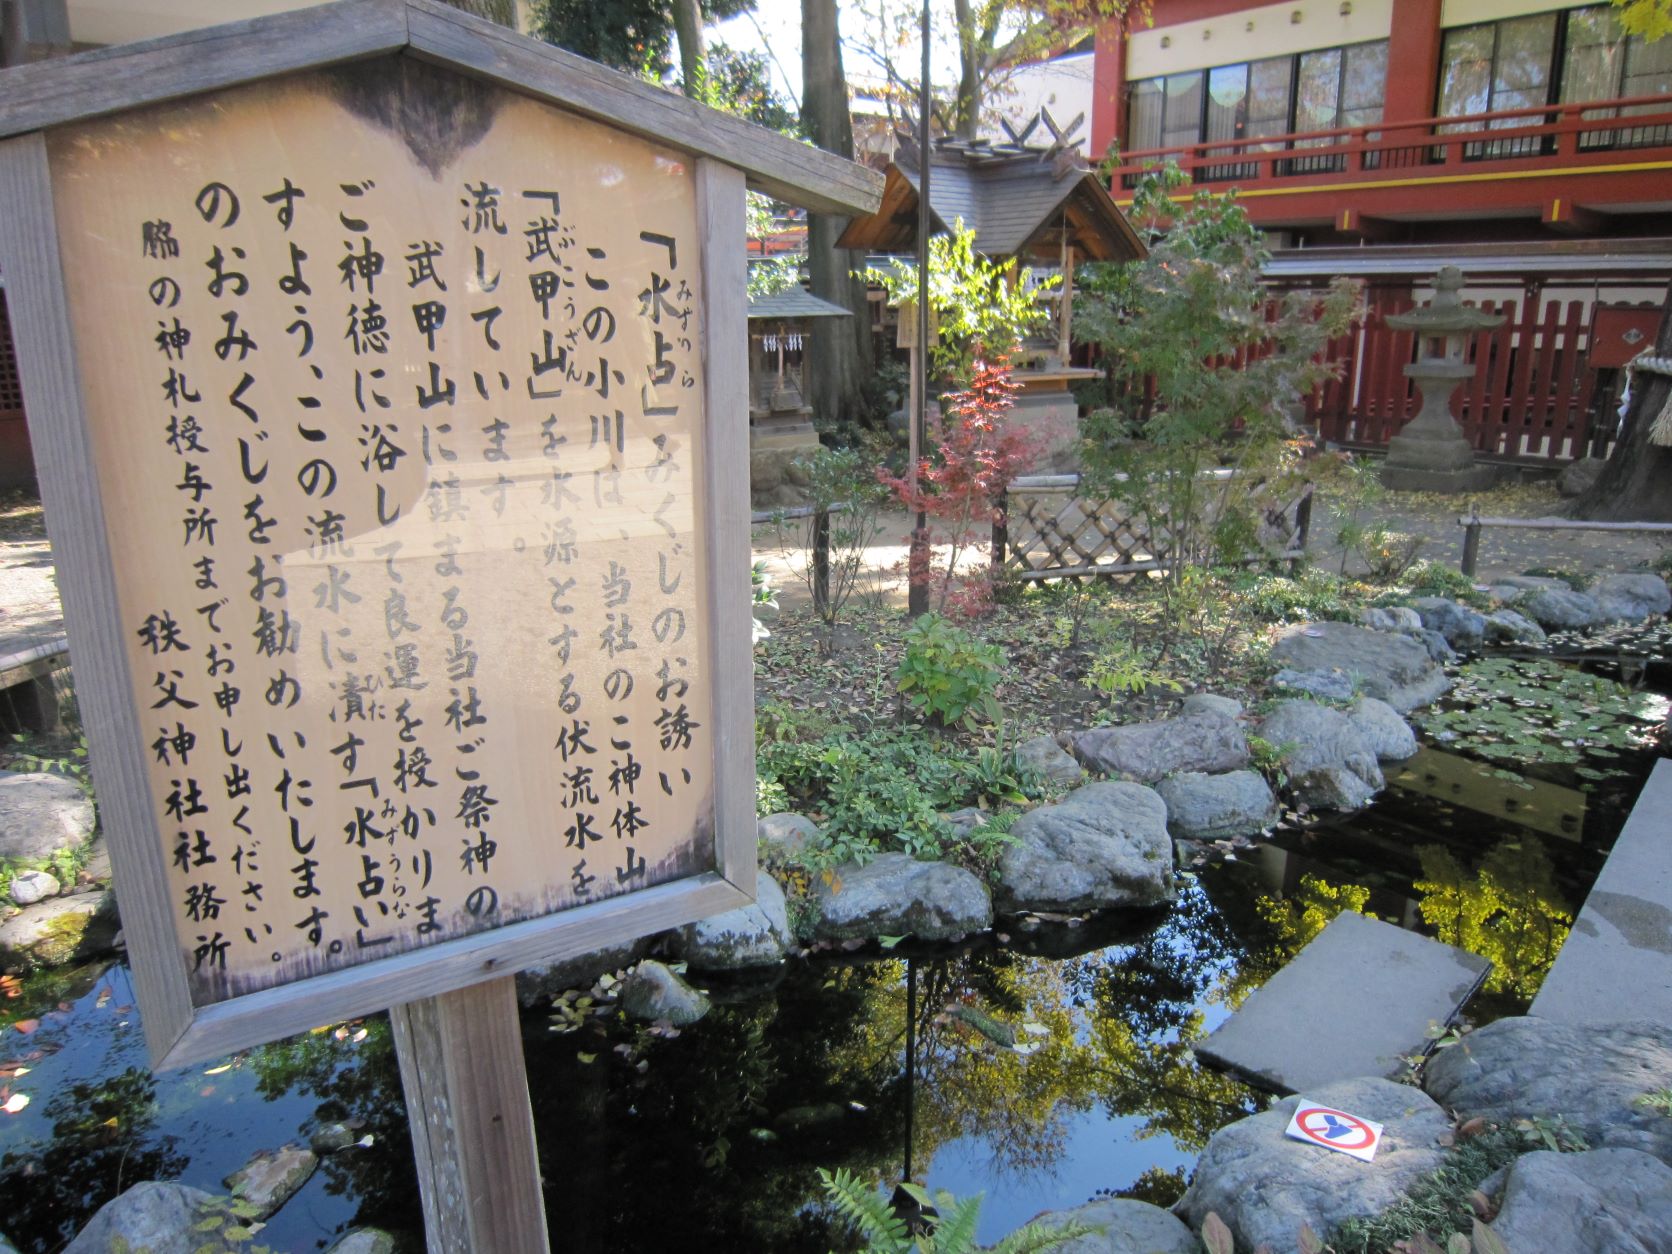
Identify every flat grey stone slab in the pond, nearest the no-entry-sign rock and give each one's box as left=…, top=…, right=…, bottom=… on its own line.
left=1195, top=911, right=1491, bottom=1093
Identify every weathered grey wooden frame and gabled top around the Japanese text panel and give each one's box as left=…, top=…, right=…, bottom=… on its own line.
left=0, top=0, right=881, bottom=1068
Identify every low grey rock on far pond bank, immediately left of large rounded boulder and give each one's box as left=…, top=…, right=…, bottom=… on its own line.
left=814, top=853, right=993, bottom=940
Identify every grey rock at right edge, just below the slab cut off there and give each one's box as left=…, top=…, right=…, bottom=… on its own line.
left=1423, top=1015, right=1672, bottom=1164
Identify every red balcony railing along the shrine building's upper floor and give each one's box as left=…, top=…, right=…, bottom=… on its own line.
left=1112, top=94, right=1672, bottom=189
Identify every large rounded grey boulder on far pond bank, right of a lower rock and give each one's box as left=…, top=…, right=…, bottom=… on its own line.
left=997, top=782, right=1172, bottom=913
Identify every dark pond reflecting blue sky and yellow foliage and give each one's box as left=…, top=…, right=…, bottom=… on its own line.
left=0, top=642, right=1664, bottom=1251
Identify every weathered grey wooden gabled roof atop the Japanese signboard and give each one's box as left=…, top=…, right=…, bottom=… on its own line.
left=0, top=0, right=881, bottom=214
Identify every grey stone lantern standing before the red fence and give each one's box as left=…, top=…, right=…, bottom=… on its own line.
left=1381, top=266, right=1503, bottom=492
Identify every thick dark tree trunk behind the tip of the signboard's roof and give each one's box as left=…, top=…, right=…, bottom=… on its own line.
left=801, top=0, right=871, bottom=428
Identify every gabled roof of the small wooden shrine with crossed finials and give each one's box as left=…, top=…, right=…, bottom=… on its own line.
left=839, top=147, right=1144, bottom=261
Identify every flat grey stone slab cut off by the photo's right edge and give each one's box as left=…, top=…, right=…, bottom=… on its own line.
left=1530, top=759, right=1672, bottom=1025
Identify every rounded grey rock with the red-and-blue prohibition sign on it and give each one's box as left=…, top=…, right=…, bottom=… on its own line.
left=1174, top=1078, right=1451, bottom=1251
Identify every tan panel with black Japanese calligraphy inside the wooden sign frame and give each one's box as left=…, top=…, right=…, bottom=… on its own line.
left=48, top=63, right=714, bottom=1003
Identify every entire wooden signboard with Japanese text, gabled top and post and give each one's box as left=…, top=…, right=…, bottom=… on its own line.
left=0, top=0, right=879, bottom=1249
